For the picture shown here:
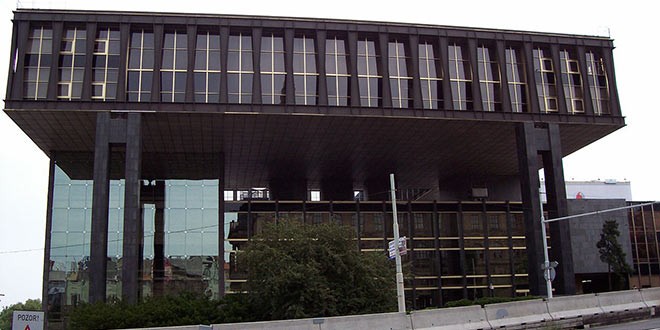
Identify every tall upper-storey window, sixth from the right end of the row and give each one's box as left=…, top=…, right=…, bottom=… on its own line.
left=449, top=43, right=473, bottom=110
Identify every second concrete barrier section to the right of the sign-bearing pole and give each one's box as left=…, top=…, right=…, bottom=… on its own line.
left=484, top=299, right=552, bottom=328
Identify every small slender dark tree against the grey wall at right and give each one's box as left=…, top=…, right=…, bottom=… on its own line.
left=596, top=220, right=632, bottom=291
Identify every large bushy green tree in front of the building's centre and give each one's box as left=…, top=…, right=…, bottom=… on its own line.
left=239, top=220, right=396, bottom=320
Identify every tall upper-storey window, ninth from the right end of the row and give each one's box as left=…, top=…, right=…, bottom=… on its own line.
left=357, top=38, right=381, bottom=107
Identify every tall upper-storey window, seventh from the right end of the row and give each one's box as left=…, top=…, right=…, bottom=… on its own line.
left=418, top=41, right=442, bottom=109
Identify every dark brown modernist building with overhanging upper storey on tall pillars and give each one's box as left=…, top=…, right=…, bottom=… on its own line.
left=4, top=10, right=625, bottom=321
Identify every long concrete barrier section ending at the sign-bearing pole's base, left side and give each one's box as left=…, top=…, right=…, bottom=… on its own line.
left=315, top=313, right=412, bottom=330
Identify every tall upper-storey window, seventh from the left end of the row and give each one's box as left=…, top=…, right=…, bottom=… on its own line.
left=227, top=33, right=254, bottom=103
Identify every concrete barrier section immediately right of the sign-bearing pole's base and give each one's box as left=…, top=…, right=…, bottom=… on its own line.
left=410, top=305, right=490, bottom=330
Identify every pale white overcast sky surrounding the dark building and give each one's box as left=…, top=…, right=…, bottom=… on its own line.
left=0, top=0, right=660, bottom=307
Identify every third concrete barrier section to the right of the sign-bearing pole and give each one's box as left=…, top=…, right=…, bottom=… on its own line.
left=546, top=293, right=604, bottom=320
